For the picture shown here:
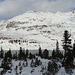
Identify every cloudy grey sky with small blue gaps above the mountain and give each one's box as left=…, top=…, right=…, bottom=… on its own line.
left=0, top=0, right=75, bottom=19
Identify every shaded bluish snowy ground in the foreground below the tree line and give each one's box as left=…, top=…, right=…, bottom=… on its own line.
left=0, top=58, right=75, bottom=75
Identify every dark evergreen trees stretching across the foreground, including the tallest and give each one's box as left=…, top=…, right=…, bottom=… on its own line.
left=0, top=30, right=75, bottom=75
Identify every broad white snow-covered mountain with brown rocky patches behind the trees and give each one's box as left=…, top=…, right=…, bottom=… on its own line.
left=0, top=11, right=75, bottom=50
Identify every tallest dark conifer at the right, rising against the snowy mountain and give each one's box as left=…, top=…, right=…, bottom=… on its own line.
left=63, top=30, right=74, bottom=67
